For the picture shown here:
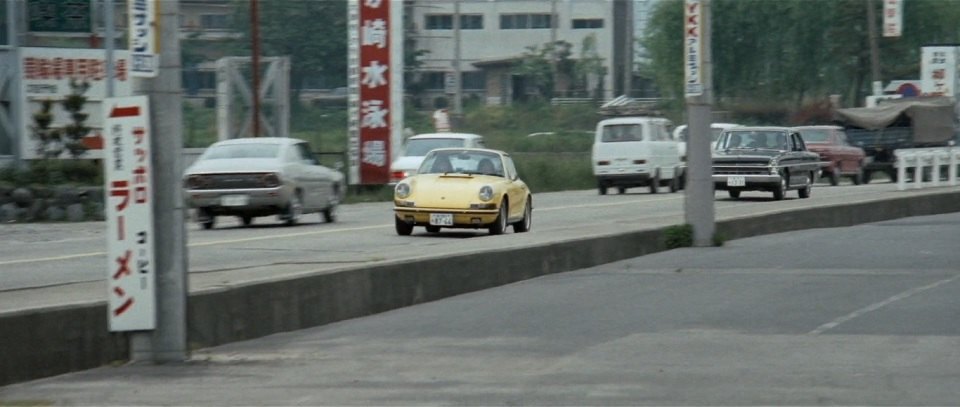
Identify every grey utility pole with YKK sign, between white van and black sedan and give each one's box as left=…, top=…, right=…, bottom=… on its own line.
left=684, top=0, right=716, bottom=247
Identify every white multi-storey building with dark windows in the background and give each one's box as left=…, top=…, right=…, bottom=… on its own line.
left=406, top=0, right=634, bottom=104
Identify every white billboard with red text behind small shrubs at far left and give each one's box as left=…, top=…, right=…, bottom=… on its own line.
left=16, top=47, right=133, bottom=159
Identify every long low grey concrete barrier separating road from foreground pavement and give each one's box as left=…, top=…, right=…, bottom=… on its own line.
left=0, top=191, right=960, bottom=385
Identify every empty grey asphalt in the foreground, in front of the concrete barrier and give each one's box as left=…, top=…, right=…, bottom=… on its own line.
left=0, top=213, right=960, bottom=406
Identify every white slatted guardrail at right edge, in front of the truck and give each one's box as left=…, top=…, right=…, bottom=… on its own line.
left=893, top=146, right=960, bottom=191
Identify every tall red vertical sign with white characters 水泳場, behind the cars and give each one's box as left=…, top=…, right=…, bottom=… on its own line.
left=347, top=0, right=403, bottom=184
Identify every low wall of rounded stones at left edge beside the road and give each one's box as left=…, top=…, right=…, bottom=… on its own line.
left=0, top=186, right=105, bottom=223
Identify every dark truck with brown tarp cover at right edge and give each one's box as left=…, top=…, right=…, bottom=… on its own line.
left=833, top=96, right=960, bottom=182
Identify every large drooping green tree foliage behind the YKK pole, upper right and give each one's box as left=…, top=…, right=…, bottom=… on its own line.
left=641, top=0, right=960, bottom=115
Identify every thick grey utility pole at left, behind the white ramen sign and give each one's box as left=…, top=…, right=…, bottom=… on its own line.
left=130, top=0, right=188, bottom=363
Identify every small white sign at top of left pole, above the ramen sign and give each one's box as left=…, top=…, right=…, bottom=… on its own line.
left=127, top=0, right=160, bottom=78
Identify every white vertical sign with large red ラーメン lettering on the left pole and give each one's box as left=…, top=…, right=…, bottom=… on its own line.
left=103, top=96, right=156, bottom=331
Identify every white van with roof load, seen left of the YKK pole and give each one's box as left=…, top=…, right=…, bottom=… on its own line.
left=591, top=117, right=683, bottom=195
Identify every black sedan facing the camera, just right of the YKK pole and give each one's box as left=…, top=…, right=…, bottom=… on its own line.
left=713, top=127, right=821, bottom=200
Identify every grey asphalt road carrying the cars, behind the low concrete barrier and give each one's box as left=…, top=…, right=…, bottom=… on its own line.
left=0, top=183, right=960, bottom=312
